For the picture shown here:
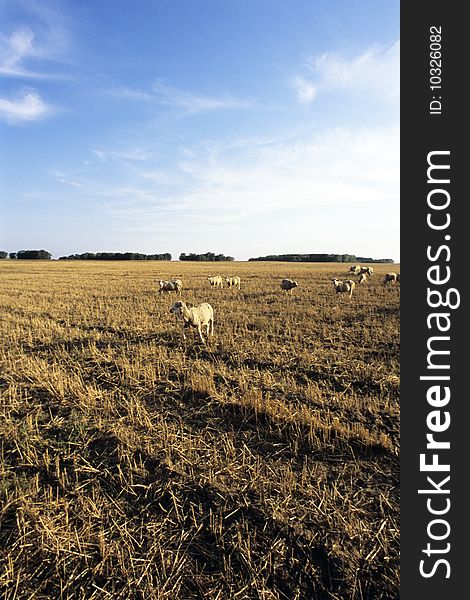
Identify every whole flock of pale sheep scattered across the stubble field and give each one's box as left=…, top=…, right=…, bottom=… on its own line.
left=159, top=265, right=400, bottom=344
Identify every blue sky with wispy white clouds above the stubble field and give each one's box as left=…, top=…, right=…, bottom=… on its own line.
left=0, top=0, right=400, bottom=261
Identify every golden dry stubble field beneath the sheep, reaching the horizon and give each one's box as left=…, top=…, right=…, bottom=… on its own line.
left=0, top=261, right=400, bottom=600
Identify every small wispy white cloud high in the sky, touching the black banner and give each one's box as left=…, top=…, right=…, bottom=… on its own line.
left=292, top=41, right=400, bottom=103
